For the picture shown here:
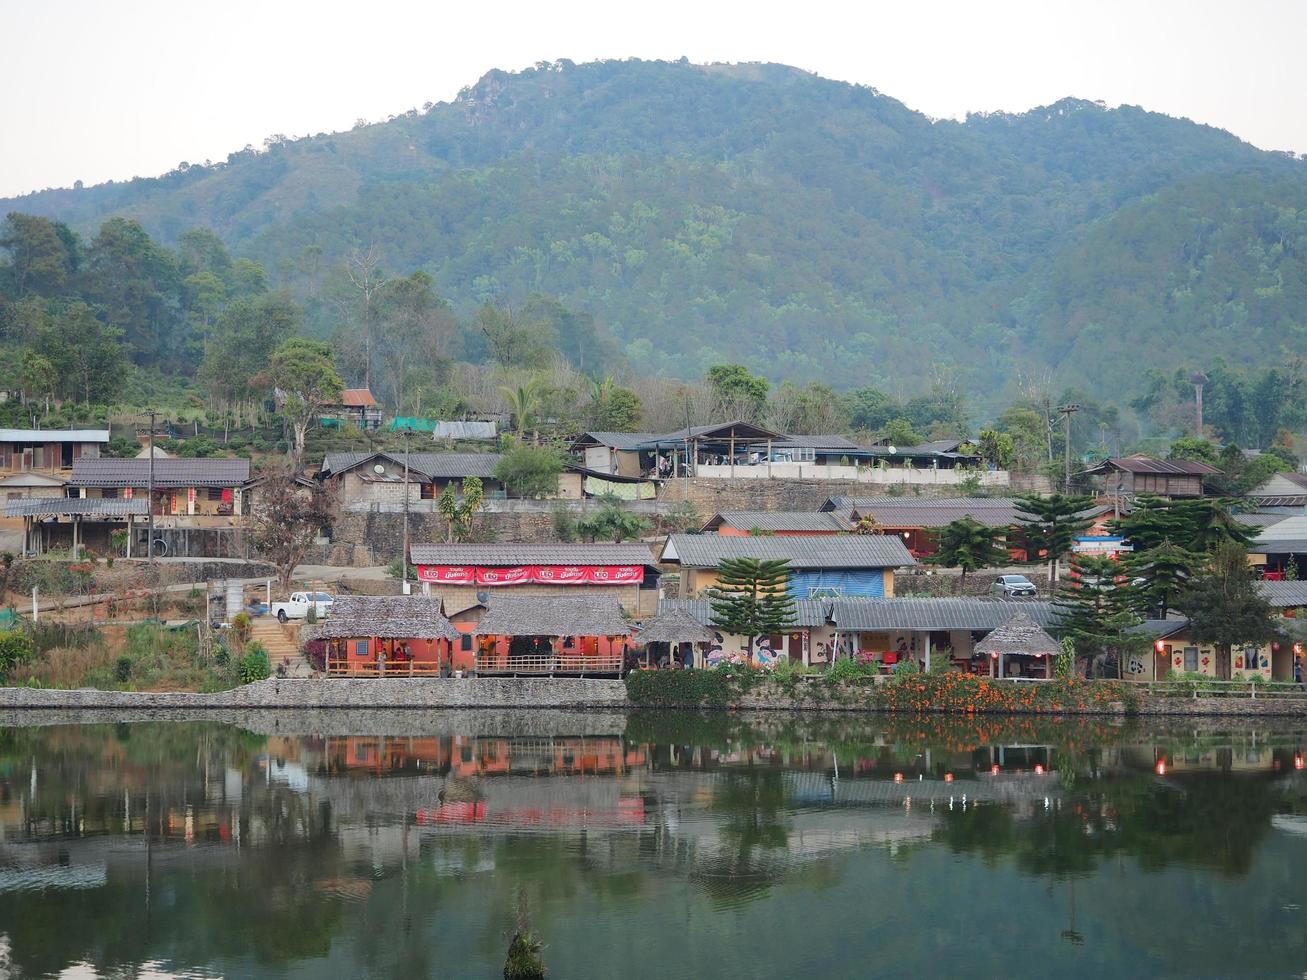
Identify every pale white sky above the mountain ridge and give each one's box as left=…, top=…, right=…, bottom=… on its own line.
left=0, top=0, right=1307, bottom=195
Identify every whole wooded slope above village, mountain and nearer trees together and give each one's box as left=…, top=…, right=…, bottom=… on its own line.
left=0, top=61, right=1307, bottom=457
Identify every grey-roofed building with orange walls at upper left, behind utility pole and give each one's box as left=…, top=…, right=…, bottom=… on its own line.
left=68, top=457, right=252, bottom=527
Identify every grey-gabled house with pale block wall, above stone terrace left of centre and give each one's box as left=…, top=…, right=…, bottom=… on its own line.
left=315, top=452, right=503, bottom=510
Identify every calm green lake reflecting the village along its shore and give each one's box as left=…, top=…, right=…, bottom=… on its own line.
left=0, top=713, right=1307, bottom=980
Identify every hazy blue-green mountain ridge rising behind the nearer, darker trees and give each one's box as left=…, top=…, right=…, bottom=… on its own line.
left=0, top=61, right=1307, bottom=404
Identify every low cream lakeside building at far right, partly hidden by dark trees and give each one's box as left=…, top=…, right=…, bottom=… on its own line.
left=1121, top=618, right=1275, bottom=681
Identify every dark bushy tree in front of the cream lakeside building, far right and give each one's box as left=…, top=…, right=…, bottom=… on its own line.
left=1176, top=541, right=1278, bottom=679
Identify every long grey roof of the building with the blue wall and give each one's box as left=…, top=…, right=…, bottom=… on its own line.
left=663, top=534, right=916, bottom=568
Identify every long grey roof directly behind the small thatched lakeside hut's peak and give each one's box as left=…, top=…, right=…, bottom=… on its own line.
left=830, top=597, right=1056, bottom=632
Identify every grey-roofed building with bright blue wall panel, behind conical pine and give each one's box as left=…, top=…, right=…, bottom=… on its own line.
left=660, top=534, right=915, bottom=598
